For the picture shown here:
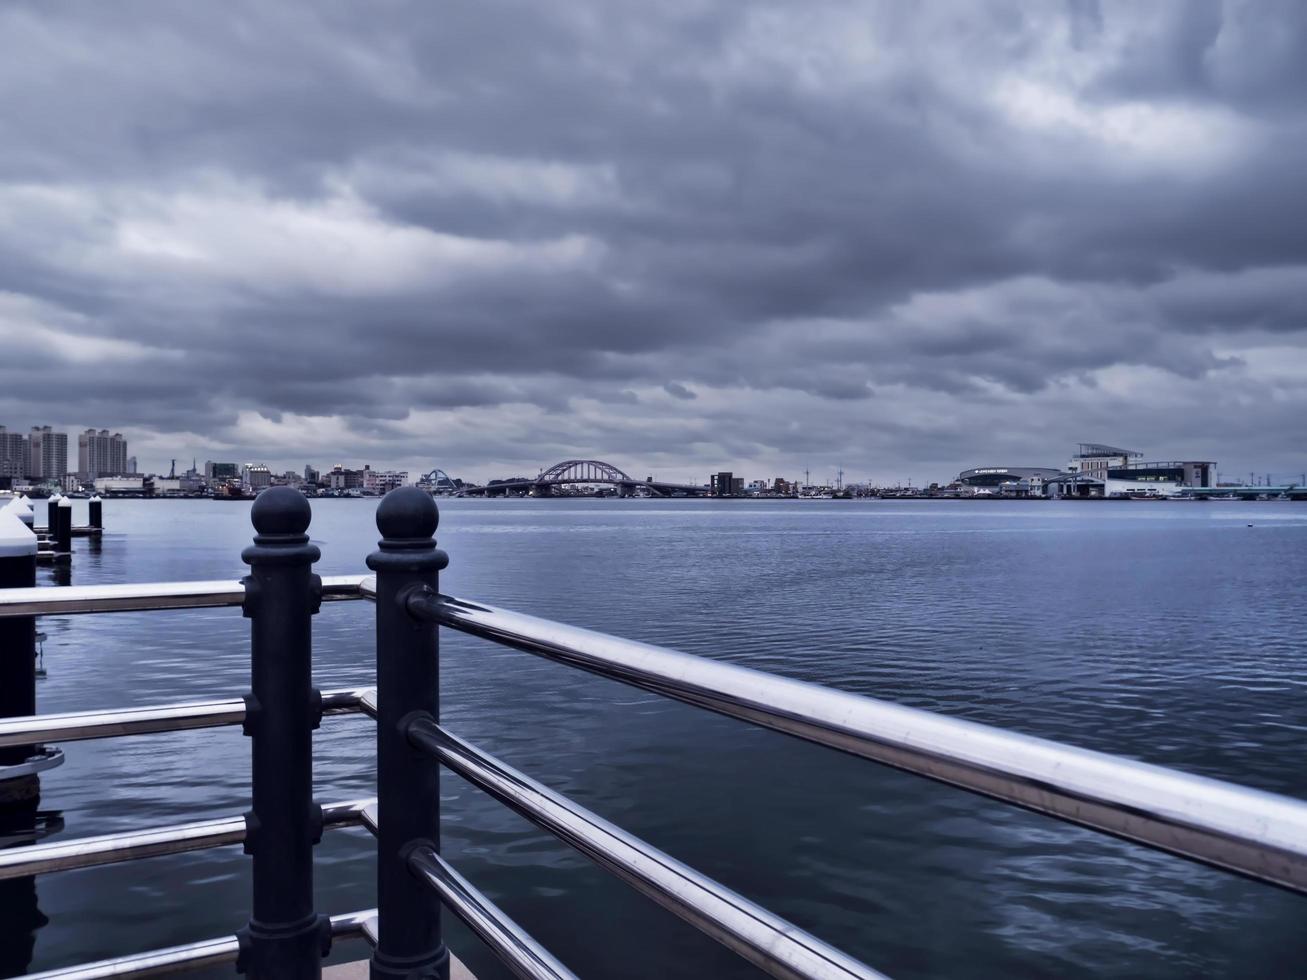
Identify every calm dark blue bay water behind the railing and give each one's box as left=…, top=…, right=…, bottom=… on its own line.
left=0, top=499, right=1307, bottom=979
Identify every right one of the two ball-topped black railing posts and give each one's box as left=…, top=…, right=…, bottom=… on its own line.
left=367, top=486, right=450, bottom=980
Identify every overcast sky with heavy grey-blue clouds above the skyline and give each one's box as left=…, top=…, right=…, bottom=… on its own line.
left=0, top=0, right=1307, bottom=482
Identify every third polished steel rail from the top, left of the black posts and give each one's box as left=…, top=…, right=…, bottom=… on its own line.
left=0, top=800, right=376, bottom=881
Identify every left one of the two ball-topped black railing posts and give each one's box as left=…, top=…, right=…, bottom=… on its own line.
left=237, top=487, right=331, bottom=980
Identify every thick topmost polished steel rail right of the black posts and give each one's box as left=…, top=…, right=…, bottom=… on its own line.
left=409, top=595, right=1307, bottom=892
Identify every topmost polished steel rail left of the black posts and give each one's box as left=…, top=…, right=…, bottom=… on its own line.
left=0, top=575, right=369, bottom=618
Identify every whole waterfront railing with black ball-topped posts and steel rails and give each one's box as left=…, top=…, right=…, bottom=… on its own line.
left=0, top=487, right=1307, bottom=980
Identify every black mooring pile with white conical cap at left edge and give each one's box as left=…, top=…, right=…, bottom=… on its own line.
left=0, top=510, right=37, bottom=783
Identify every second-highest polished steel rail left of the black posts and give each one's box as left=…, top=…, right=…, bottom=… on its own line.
left=0, top=687, right=372, bottom=747
